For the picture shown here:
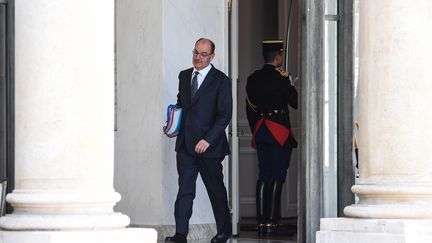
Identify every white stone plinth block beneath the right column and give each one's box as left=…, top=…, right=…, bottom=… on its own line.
left=316, top=218, right=432, bottom=243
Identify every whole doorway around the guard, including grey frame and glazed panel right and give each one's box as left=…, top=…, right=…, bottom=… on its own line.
left=230, top=0, right=354, bottom=242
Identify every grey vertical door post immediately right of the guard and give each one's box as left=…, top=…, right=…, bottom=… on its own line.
left=297, top=0, right=324, bottom=243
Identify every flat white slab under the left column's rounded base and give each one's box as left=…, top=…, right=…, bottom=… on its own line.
left=0, top=228, right=157, bottom=243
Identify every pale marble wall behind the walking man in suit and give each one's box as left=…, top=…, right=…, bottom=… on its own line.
left=115, top=0, right=227, bottom=225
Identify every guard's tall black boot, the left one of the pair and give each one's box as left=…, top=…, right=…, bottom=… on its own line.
left=255, top=180, right=269, bottom=235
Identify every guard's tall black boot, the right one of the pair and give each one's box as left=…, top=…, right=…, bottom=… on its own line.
left=267, top=181, right=283, bottom=233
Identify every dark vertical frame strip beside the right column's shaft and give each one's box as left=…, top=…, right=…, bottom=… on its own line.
left=337, top=0, right=355, bottom=217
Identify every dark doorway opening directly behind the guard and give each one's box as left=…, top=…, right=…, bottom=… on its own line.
left=231, top=0, right=300, bottom=239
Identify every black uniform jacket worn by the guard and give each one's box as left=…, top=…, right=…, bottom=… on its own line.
left=246, top=64, right=298, bottom=147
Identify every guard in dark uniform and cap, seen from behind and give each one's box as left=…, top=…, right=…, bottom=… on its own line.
left=246, top=40, right=298, bottom=235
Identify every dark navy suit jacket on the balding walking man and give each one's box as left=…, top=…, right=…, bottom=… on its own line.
left=176, top=66, right=232, bottom=158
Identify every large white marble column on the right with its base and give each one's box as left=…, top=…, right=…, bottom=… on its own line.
left=318, top=0, right=432, bottom=243
